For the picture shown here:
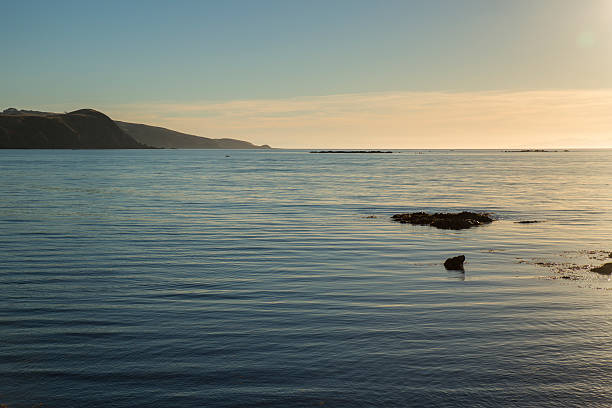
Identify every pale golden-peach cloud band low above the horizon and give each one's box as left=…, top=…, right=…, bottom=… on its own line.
left=101, top=89, right=612, bottom=148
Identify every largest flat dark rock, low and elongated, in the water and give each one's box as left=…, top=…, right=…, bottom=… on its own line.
left=391, top=211, right=493, bottom=230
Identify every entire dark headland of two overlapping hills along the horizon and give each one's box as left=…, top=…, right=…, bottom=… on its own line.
left=0, top=108, right=270, bottom=149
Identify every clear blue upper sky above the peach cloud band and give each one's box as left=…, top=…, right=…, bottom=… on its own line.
left=0, top=0, right=612, bottom=147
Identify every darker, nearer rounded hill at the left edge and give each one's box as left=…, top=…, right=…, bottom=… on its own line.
left=0, top=109, right=149, bottom=149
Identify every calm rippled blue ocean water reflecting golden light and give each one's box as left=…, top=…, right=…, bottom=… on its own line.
left=0, top=150, right=612, bottom=408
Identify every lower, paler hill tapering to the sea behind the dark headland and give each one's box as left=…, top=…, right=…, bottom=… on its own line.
left=115, top=121, right=270, bottom=149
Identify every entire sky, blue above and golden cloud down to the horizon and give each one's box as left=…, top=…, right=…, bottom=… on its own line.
left=0, top=0, right=612, bottom=148
